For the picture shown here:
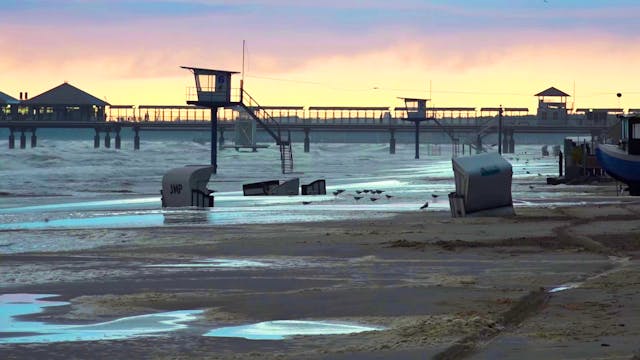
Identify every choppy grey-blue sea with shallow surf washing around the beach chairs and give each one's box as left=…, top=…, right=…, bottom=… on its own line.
left=0, top=136, right=616, bottom=254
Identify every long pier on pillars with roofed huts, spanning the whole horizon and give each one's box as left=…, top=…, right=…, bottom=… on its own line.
left=0, top=83, right=638, bottom=157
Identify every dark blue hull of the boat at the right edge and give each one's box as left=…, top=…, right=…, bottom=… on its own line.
left=596, top=145, right=640, bottom=193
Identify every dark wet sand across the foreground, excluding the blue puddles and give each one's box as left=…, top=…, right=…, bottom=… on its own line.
left=0, top=201, right=640, bottom=359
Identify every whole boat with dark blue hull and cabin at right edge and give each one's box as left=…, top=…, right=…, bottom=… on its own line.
left=596, top=116, right=640, bottom=196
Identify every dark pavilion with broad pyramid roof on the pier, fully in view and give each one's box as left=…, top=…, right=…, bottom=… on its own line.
left=21, top=82, right=109, bottom=121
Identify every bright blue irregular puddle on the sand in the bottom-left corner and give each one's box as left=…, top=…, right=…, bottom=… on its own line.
left=0, top=294, right=202, bottom=344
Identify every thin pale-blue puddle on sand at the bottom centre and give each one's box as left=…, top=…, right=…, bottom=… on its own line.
left=204, top=320, right=384, bottom=340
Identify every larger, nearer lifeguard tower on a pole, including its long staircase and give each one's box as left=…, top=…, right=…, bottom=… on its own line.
left=181, top=66, right=293, bottom=174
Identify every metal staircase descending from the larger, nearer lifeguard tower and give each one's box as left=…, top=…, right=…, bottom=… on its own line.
left=238, top=89, right=293, bottom=174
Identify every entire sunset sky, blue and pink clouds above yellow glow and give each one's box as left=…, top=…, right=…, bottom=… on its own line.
left=0, top=0, right=640, bottom=112
